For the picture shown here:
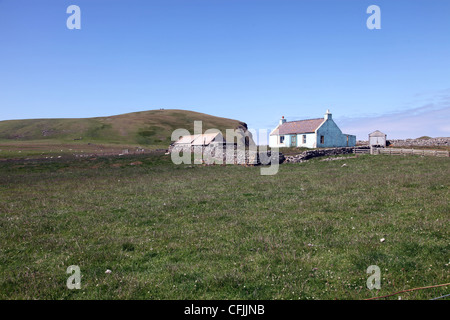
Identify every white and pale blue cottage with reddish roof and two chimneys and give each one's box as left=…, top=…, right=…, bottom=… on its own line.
left=269, top=110, right=356, bottom=148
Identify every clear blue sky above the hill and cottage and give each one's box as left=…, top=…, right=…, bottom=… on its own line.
left=0, top=0, right=450, bottom=139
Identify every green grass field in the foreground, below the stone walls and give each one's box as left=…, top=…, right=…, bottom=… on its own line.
left=0, top=155, right=450, bottom=299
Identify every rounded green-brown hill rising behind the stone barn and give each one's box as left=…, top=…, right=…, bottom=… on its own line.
left=0, top=109, right=247, bottom=146
